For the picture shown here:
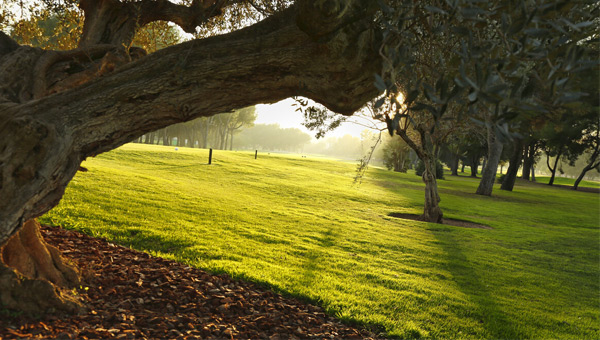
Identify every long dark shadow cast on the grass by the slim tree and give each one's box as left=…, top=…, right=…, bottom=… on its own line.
left=434, top=233, right=526, bottom=339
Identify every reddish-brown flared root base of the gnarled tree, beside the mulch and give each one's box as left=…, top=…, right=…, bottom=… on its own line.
left=0, top=220, right=82, bottom=314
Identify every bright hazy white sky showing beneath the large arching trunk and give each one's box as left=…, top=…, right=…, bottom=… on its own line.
left=255, top=99, right=380, bottom=138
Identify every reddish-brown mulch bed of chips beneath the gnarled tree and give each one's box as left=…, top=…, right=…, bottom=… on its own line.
left=0, top=226, right=376, bottom=339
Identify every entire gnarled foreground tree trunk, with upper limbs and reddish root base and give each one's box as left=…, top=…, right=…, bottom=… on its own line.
left=0, top=0, right=381, bottom=312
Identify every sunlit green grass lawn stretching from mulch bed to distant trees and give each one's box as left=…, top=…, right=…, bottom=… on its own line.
left=42, top=144, right=600, bottom=339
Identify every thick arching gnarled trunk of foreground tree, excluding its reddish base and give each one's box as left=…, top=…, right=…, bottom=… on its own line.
left=0, top=0, right=380, bottom=250
